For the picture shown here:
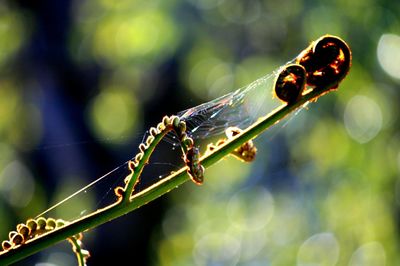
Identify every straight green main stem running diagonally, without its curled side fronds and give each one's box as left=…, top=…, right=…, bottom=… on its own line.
left=0, top=88, right=330, bottom=265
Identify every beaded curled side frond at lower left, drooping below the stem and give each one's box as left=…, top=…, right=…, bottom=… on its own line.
left=0, top=217, right=90, bottom=266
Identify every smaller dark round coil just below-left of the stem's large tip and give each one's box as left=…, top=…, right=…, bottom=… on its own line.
left=274, top=64, right=306, bottom=104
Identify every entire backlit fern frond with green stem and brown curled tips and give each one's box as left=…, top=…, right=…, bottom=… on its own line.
left=0, top=35, right=351, bottom=265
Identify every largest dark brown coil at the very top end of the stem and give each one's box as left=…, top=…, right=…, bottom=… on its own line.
left=296, top=35, right=351, bottom=89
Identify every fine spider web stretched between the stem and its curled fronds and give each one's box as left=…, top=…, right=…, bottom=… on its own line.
left=38, top=61, right=302, bottom=219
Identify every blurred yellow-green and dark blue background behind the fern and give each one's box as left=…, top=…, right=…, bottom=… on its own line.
left=0, top=0, right=400, bottom=266
